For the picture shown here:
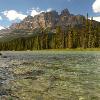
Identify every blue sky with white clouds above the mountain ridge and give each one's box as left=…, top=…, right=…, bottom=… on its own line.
left=0, top=0, right=100, bottom=28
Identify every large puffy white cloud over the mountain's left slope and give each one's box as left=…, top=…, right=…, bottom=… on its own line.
left=2, top=10, right=27, bottom=21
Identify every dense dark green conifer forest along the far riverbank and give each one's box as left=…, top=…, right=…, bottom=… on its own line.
left=0, top=15, right=100, bottom=50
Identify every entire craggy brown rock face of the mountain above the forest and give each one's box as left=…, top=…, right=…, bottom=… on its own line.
left=10, top=9, right=85, bottom=30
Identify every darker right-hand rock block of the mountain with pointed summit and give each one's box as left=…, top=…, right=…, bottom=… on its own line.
left=59, top=9, right=85, bottom=27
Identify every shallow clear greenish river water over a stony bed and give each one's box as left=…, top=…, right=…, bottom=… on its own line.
left=0, top=51, right=100, bottom=100
